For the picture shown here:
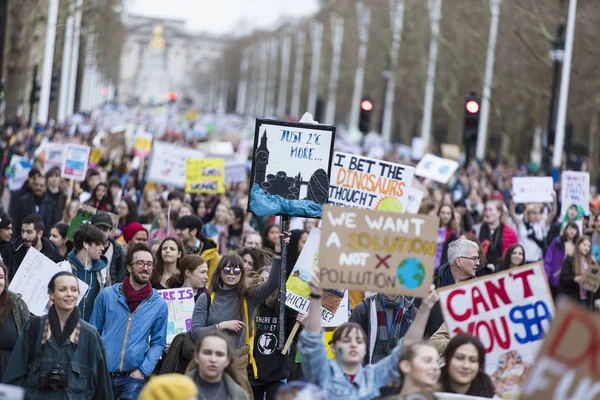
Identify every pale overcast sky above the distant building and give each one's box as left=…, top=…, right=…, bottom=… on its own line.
left=126, top=0, right=318, bottom=35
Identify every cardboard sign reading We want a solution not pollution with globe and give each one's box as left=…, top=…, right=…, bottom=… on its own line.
left=319, top=205, right=439, bottom=297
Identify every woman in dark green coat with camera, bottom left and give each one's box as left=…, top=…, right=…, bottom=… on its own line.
left=3, top=271, right=113, bottom=400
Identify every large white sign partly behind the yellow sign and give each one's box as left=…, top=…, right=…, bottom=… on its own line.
left=146, top=140, right=205, bottom=189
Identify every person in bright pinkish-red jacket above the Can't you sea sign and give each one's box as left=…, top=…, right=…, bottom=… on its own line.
left=473, top=200, right=519, bottom=266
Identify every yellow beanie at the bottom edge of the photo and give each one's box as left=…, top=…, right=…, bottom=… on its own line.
left=138, top=374, right=198, bottom=400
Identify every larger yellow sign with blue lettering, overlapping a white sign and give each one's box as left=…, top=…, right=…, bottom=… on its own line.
left=185, top=158, right=225, bottom=194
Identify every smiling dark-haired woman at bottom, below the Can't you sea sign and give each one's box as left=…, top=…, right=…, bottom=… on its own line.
left=440, top=333, right=494, bottom=398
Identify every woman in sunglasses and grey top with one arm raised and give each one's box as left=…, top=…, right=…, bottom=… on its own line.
left=191, top=231, right=287, bottom=395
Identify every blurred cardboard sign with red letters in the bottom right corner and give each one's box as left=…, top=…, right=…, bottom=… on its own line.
left=519, top=298, right=600, bottom=400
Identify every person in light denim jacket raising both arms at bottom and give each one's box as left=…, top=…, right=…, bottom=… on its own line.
left=299, top=270, right=438, bottom=400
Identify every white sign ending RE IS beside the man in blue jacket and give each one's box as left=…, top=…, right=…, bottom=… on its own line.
left=158, top=287, right=196, bottom=344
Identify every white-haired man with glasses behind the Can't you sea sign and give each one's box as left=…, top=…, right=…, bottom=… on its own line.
left=425, top=239, right=480, bottom=337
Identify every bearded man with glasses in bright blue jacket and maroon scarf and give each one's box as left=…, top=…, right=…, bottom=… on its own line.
left=90, top=243, right=169, bottom=400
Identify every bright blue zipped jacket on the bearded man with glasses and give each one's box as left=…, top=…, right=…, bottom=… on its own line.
left=90, top=283, right=169, bottom=377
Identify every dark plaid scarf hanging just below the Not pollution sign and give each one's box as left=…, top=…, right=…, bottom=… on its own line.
left=371, top=295, right=405, bottom=357
